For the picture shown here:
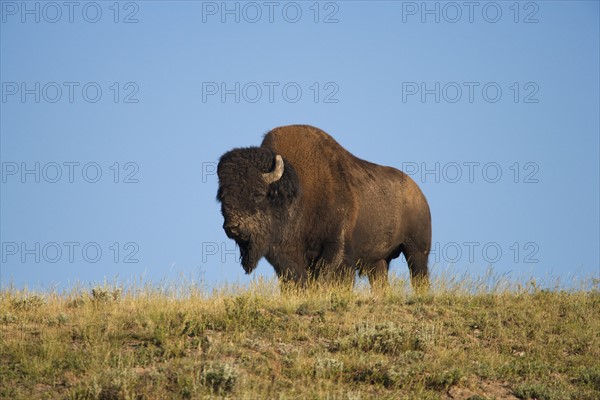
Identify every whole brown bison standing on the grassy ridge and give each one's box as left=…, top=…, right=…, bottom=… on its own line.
left=217, top=125, right=431, bottom=287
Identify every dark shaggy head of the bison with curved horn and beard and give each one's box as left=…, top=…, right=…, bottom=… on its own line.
left=217, top=147, right=299, bottom=273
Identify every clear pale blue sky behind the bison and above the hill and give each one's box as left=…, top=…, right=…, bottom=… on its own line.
left=0, top=1, right=600, bottom=289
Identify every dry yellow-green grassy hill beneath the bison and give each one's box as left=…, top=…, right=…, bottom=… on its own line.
left=0, top=280, right=600, bottom=400
